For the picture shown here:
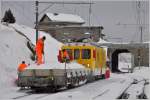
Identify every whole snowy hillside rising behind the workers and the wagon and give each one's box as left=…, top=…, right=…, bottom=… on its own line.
left=0, top=24, right=82, bottom=92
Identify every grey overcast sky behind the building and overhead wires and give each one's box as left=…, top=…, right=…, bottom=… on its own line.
left=2, top=0, right=149, bottom=42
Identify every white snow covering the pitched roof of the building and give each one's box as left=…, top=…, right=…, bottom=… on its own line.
left=46, top=13, right=85, bottom=23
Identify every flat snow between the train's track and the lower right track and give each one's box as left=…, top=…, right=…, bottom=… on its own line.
left=39, top=67, right=150, bottom=100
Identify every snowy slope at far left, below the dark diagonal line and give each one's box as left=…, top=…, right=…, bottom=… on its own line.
left=0, top=25, right=32, bottom=90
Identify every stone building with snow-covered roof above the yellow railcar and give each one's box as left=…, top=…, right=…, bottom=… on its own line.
left=38, top=13, right=104, bottom=42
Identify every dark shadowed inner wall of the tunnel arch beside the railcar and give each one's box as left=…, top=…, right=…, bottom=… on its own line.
left=111, top=49, right=130, bottom=72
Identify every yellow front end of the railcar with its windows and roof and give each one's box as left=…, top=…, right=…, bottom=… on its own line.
left=58, top=43, right=96, bottom=69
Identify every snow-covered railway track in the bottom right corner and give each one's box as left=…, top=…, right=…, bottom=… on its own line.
left=117, top=79, right=149, bottom=99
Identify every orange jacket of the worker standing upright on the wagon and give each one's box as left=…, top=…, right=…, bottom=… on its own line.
left=35, top=38, right=44, bottom=53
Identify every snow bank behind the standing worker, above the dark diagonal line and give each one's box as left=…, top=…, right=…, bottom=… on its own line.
left=11, top=24, right=62, bottom=64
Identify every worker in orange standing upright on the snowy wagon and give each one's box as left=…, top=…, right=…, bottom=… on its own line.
left=35, top=36, right=46, bottom=65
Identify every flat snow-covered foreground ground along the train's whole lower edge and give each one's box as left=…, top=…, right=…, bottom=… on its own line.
left=1, top=67, right=150, bottom=100
